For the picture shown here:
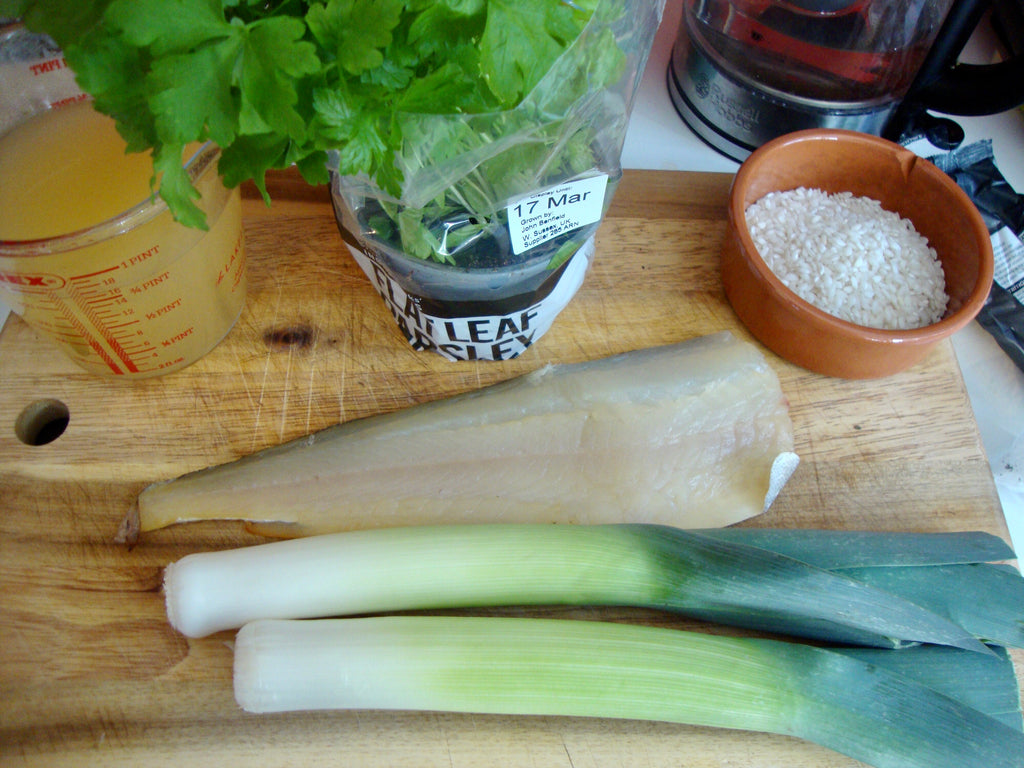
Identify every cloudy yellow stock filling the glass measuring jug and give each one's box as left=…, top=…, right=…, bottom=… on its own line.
left=0, top=102, right=245, bottom=376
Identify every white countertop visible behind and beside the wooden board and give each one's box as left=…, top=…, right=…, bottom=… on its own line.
left=623, top=0, right=1024, bottom=552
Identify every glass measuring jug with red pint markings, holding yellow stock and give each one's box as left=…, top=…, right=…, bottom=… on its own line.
left=0, top=26, right=246, bottom=378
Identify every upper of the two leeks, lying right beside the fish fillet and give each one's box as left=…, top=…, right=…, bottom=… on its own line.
left=164, top=524, right=999, bottom=652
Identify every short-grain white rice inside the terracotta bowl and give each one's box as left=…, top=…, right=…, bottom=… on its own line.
left=746, top=187, right=949, bottom=331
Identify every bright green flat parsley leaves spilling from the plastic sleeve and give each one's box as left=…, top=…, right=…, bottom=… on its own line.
left=18, top=0, right=629, bottom=268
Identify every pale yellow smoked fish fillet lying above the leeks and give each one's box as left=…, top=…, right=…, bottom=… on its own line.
left=122, top=332, right=798, bottom=540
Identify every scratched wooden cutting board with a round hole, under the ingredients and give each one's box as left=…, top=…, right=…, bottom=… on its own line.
left=0, top=167, right=1021, bottom=768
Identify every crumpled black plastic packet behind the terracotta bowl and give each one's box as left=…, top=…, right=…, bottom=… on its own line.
left=929, top=139, right=1024, bottom=371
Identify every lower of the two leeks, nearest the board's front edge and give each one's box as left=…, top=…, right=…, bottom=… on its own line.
left=234, top=616, right=1024, bottom=768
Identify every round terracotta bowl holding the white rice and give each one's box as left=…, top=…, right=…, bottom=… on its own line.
left=722, top=130, right=992, bottom=379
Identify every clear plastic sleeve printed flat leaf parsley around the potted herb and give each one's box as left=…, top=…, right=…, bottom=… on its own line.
left=331, top=0, right=664, bottom=359
